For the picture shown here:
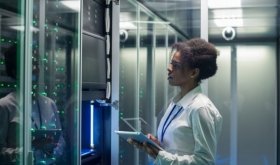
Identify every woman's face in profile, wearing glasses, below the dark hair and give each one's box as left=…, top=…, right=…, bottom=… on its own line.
left=167, top=52, right=194, bottom=87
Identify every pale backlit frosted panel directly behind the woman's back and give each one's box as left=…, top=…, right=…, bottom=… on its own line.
left=208, top=42, right=277, bottom=165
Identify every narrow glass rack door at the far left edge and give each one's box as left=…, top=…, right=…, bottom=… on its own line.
left=0, top=0, right=26, bottom=164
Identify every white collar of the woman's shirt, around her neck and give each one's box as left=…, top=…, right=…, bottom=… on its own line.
left=172, top=85, right=202, bottom=108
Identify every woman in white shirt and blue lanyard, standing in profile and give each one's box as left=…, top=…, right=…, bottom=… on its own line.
left=128, top=38, right=222, bottom=165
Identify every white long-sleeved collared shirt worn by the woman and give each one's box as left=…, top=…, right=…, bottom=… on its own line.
left=155, top=86, right=222, bottom=165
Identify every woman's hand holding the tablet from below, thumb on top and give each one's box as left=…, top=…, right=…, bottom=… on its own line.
left=127, top=134, right=160, bottom=159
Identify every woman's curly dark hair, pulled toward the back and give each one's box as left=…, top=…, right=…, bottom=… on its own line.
left=172, top=38, right=218, bottom=82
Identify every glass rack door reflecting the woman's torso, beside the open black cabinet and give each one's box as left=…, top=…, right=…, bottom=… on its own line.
left=27, top=0, right=81, bottom=165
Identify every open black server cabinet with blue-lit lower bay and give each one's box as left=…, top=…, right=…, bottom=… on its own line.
left=81, top=0, right=111, bottom=165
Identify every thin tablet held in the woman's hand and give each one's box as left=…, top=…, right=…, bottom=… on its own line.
left=115, top=131, right=163, bottom=150
